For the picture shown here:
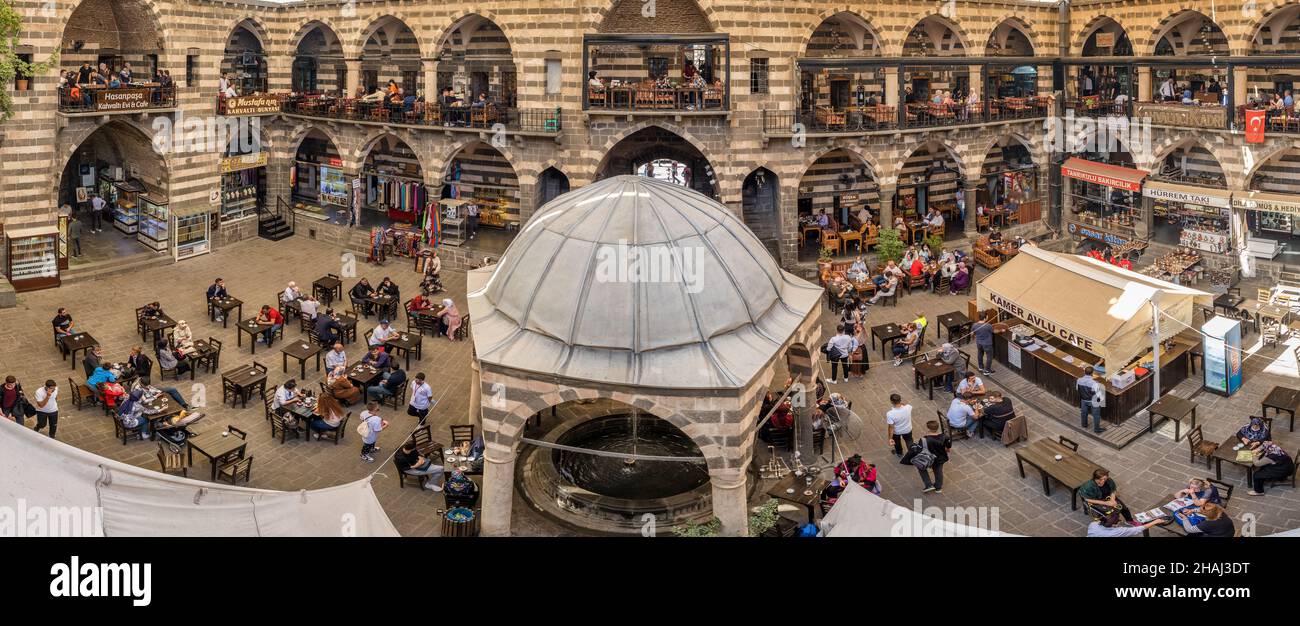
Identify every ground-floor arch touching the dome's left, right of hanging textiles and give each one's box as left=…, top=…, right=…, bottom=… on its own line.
left=438, top=142, right=521, bottom=256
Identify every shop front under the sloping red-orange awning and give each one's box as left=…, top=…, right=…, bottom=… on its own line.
left=1061, top=157, right=1147, bottom=247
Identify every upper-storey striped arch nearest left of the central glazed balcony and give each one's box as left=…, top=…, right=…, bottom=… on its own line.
left=439, top=14, right=519, bottom=108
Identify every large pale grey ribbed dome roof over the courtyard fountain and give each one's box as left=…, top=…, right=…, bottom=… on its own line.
left=469, top=175, right=822, bottom=388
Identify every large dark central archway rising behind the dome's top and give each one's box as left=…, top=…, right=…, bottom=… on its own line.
left=595, top=126, right=719, bottom=199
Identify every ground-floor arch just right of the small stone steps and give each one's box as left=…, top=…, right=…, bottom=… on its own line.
left=289, top=127, right=352, bottom=223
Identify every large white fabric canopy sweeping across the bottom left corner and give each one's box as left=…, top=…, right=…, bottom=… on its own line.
left=0, top=419, right=398, bottom=536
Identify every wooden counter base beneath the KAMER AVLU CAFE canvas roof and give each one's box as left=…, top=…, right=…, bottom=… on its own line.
left=993, top=321, right=1197, bottom=423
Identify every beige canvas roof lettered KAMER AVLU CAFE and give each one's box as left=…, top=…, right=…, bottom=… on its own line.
left=976, top=245, right=1213, bottom=371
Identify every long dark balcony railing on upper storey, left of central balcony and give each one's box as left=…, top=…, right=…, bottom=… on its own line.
left=282, top=96, right=562, bottom=134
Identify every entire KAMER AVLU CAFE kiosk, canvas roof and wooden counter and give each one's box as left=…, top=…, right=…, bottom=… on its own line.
left=976, top=247, right=1213, bottom=423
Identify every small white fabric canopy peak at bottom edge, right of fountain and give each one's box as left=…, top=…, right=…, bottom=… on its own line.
left=822, top=482, right=1019, bottom=536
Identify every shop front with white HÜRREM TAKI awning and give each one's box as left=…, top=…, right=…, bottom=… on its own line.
left=1143, top=181, right=1235, bottom=255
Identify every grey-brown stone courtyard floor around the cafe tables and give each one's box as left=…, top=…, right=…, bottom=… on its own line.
left=0, top=236, right=1300, bottom=536
